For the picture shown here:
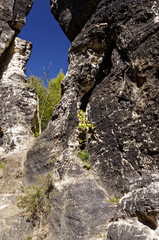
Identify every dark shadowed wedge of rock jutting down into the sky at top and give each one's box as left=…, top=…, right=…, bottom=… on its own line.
left=50, top=0, right=100, bottom=41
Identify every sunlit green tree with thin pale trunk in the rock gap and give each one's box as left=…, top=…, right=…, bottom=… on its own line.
left=27, top=71, right=64, bottom=137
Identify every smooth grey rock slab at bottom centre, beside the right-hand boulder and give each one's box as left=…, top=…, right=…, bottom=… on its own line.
left=48, top=164, right=116, bottom=240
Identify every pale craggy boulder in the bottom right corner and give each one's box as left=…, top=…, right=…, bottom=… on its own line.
left=107, top=173, right=159, bottom=240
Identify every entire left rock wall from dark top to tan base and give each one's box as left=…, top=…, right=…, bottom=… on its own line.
left=0, top=0, right=36, bottom=240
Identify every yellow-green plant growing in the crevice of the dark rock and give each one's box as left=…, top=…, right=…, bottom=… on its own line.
left=77, top=110, right=95, bottom=149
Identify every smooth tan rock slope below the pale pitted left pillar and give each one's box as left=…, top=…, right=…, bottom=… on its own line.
left=0, top=147, right=33, bottom=240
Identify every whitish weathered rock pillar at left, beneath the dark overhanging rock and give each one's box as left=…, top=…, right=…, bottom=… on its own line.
left=0, top=38, right=36, bottom=156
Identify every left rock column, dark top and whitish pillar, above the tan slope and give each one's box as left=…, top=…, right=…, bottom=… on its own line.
left=0, top=1, right=36, bottom=157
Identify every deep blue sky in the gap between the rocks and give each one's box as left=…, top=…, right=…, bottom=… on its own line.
left=18, top=0, right=71, bottom=78
